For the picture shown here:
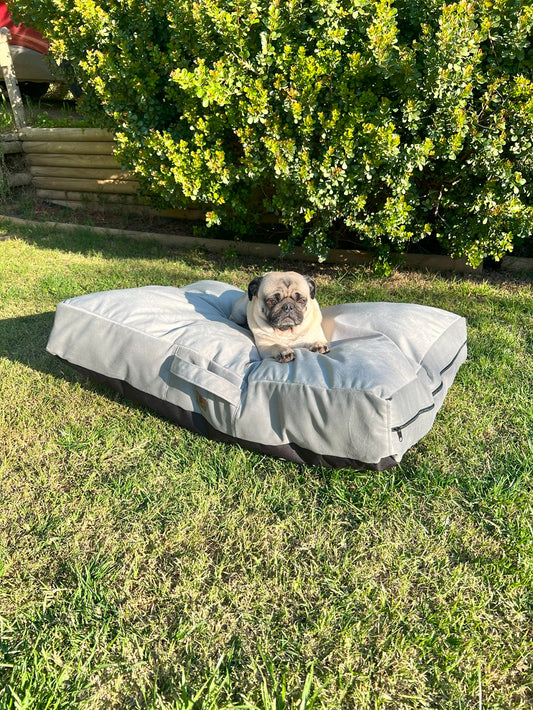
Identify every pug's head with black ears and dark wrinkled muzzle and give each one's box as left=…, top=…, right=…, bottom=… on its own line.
left=248, top=271, right=316, bottom=331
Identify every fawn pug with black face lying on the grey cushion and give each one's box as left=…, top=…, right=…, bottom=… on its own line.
left=230, top=271, right=329, bottom=362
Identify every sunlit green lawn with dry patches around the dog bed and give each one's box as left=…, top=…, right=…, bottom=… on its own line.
left=0, top=222, right=533, bottom=710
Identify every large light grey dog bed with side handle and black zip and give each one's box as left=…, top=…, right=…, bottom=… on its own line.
left=47, top=281, right=466, bottom=470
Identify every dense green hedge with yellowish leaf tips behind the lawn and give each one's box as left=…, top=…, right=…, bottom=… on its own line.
left=10, top=0, right=533, bottom=265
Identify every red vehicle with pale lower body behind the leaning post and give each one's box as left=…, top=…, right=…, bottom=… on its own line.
left=0, top=2, right=54, bottom=98
